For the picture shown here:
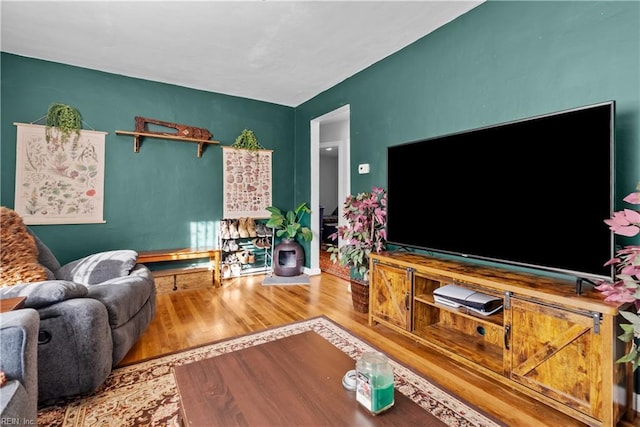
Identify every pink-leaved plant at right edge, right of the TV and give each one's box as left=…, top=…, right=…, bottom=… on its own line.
left=596, top=184, right=640, bottom=371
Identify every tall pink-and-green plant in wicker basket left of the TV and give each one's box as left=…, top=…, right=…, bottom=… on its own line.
left=328, top=187, right=387, bottom=313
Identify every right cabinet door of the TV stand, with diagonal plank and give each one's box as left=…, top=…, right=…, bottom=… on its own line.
left=509, top=298, right=610, bottom=419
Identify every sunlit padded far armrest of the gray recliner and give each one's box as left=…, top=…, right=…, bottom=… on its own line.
left=54, top=249, right=138, bottom=285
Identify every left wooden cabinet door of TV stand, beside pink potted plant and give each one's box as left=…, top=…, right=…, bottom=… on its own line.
left=369, top=263, right=413, bottom=331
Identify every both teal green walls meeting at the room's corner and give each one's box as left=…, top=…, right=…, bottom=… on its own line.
left=0, top=1, right=640, bottom=265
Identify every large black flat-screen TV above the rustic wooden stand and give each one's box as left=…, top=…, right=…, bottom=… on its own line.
left=387, top=101, right=615, bottom=279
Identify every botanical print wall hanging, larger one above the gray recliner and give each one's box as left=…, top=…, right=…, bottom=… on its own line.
left=14, top=123, right=107, bottom=225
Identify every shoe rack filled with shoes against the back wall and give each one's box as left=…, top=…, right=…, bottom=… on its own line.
left=218, top=217, right=273, bottom=280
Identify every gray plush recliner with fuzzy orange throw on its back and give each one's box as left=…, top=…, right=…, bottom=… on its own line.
left=0, top=233, right=156, bottom=404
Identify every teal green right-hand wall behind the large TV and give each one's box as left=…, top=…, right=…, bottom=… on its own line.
left=296, top=1, right=640, bottom=216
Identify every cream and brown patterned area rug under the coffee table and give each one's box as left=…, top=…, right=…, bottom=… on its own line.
left=38, top=316, right=502, bottom=427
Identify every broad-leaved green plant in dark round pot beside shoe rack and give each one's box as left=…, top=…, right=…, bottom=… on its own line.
left=266, top=203, right=313, bottom=277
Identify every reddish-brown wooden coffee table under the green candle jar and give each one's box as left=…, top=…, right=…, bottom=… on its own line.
left=174, top=332, right=445, bottom=427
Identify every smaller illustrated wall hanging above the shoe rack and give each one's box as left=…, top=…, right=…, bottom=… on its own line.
left=222, top=147, right=273, bottom=218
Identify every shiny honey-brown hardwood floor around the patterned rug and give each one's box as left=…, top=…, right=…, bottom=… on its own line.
left=121, top=273, right=636, bottom=427
